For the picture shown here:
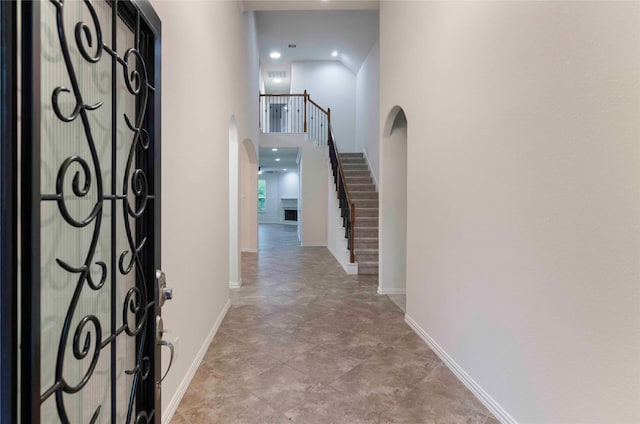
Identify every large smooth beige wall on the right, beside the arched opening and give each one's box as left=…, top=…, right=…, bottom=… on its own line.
left=380, top=1, right=640, bottom=423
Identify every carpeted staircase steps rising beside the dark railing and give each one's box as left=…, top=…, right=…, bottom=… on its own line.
left=339, top=153, right=378, bottom=275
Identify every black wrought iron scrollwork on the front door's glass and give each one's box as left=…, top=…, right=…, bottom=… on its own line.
left=40, top=0, right=154, bottom=423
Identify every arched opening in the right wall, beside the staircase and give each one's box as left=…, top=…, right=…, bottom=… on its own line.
left=378, top=106, right=407, bottom=309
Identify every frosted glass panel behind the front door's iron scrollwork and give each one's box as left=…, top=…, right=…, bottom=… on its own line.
left=40, top=1, right=142, bottom=423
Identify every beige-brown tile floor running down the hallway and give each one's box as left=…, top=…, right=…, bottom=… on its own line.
left=172, top=224, right=497, bottom=424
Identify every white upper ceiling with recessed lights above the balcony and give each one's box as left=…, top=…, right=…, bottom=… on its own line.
left=256, top=9, right=379, bottom=93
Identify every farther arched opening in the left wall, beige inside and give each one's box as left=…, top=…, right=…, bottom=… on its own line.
left=240, top=139, right=258, bottom=253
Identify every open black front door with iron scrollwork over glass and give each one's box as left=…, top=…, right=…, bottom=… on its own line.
left=19, top=0, right=169, bottom=423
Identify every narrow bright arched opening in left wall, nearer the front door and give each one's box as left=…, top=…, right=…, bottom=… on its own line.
left=229, top=116, right=242, bottom=288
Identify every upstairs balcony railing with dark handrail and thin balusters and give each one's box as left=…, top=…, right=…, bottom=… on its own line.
left=260, top=90, right=331, bottom=146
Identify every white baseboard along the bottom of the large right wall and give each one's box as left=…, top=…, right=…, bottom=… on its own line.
left=404, top=314, right=517, bottom=424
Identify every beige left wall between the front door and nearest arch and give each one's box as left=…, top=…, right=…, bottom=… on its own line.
left=153, top=1, right=257, bottom=420
